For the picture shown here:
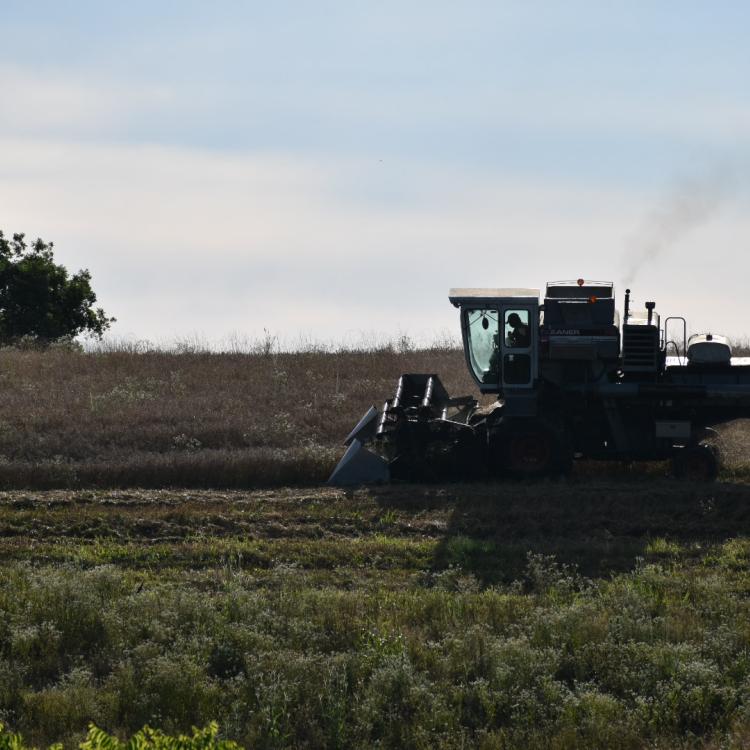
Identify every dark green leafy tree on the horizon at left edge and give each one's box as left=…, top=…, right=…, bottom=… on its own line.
left=0, top=231, right=115, bottom=343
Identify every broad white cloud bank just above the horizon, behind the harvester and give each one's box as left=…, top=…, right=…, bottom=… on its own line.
left=0, top=139, right=750, bottom=340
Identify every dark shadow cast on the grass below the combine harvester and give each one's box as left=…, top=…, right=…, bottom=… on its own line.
left=373, top=479, right=750, bottom=585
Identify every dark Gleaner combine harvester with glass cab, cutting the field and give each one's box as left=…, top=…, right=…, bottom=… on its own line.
left=329, top=279, right=750, bottom=485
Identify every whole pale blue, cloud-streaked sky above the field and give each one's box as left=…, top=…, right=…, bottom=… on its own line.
left=0, top=0, right=750, bottom=343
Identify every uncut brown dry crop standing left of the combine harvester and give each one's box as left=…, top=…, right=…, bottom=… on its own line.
left=0, top=347, right=471, bottom=488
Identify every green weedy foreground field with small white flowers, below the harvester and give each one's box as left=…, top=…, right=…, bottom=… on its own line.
left=0, top=481, right=750, bottom=749
